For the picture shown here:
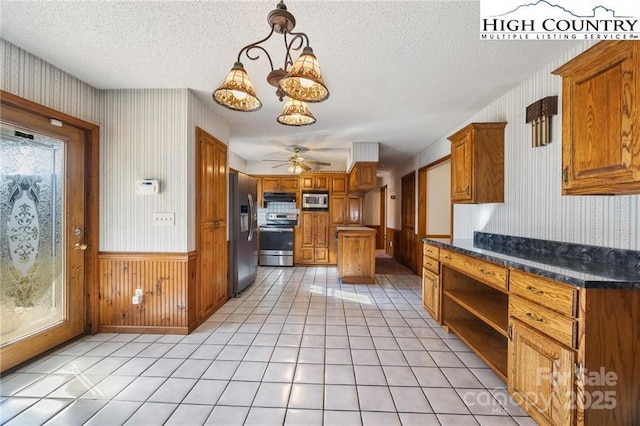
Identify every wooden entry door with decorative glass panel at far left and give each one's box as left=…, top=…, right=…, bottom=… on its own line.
left=0, top=101, right=92, bottom=371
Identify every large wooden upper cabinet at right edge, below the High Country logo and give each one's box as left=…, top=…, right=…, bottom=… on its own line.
left=553, top=41, right=640, bottom=195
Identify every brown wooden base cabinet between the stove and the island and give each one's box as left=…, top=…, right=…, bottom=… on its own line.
left=296, top=212, right=330, bottom=264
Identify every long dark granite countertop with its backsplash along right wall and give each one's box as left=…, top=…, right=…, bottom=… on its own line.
left=422, top=232, right=640, bottom=290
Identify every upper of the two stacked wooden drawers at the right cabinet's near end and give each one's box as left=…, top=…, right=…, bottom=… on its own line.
left=509, top=271, right=578, bottom=317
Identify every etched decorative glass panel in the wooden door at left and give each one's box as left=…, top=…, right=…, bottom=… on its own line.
left=0, top=125, right=66, bottom=346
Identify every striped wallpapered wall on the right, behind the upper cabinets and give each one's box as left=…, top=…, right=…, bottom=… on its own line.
left=389, top=43, right=640, bottom=250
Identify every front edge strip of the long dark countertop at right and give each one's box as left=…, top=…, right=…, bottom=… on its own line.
left=422, top=238, right=640, bottom=290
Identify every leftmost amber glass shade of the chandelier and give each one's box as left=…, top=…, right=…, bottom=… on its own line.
left=213, top=62, right=262, bottom=112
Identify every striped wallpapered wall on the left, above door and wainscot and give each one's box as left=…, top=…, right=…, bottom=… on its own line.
left=0, top=40, right=229, bottom=252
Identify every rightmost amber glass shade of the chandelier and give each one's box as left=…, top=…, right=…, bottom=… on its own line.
left=278, top=46, right=329, bottom=102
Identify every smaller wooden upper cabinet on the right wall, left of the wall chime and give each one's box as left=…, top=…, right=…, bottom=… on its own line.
left=449, top=123, right=507, bottom=203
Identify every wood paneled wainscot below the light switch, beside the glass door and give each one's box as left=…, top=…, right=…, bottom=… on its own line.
left=98, top=252, right=197, bottom=334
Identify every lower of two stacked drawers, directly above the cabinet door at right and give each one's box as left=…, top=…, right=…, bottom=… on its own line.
left=509, top=295, right=578, bottom=348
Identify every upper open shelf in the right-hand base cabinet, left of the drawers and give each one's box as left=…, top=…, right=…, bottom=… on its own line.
left=444, top=290, right=509, bottom=337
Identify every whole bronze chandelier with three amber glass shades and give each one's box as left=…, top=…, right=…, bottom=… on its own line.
left=213, top=1, right=329, bottom=126
